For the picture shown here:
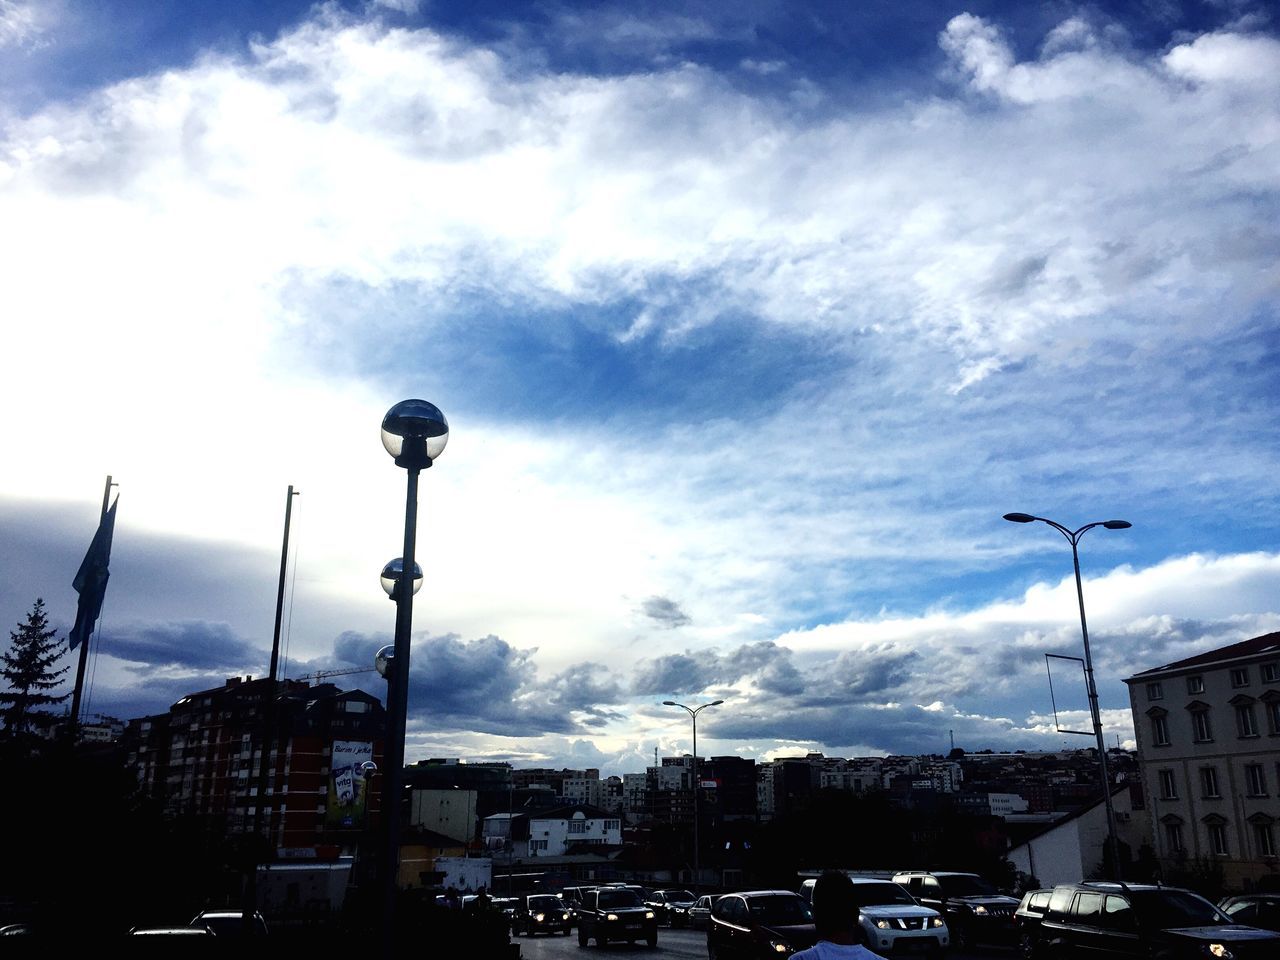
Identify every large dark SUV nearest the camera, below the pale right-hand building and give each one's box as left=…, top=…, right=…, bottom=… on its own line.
left=1033, top=882, right=1280, bottom=960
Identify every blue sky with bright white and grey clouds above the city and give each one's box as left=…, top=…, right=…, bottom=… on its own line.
left=0, top=0, right=1280, bottom=773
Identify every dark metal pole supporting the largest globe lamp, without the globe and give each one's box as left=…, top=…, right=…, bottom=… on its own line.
left=383, top=461, right=419, bottom=956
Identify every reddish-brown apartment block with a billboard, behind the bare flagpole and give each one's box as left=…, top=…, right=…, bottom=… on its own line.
left=124, top=677, right=387, bottom=849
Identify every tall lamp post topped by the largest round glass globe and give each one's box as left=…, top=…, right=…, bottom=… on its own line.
left=379, top=399, right=449, bottom=955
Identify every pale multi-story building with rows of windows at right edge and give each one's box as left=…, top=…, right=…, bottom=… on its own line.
left=1125, top=634, right=1280, bottom=888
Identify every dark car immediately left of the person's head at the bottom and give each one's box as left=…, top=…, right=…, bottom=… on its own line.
left=707, top=890, right=818, bottom=960
